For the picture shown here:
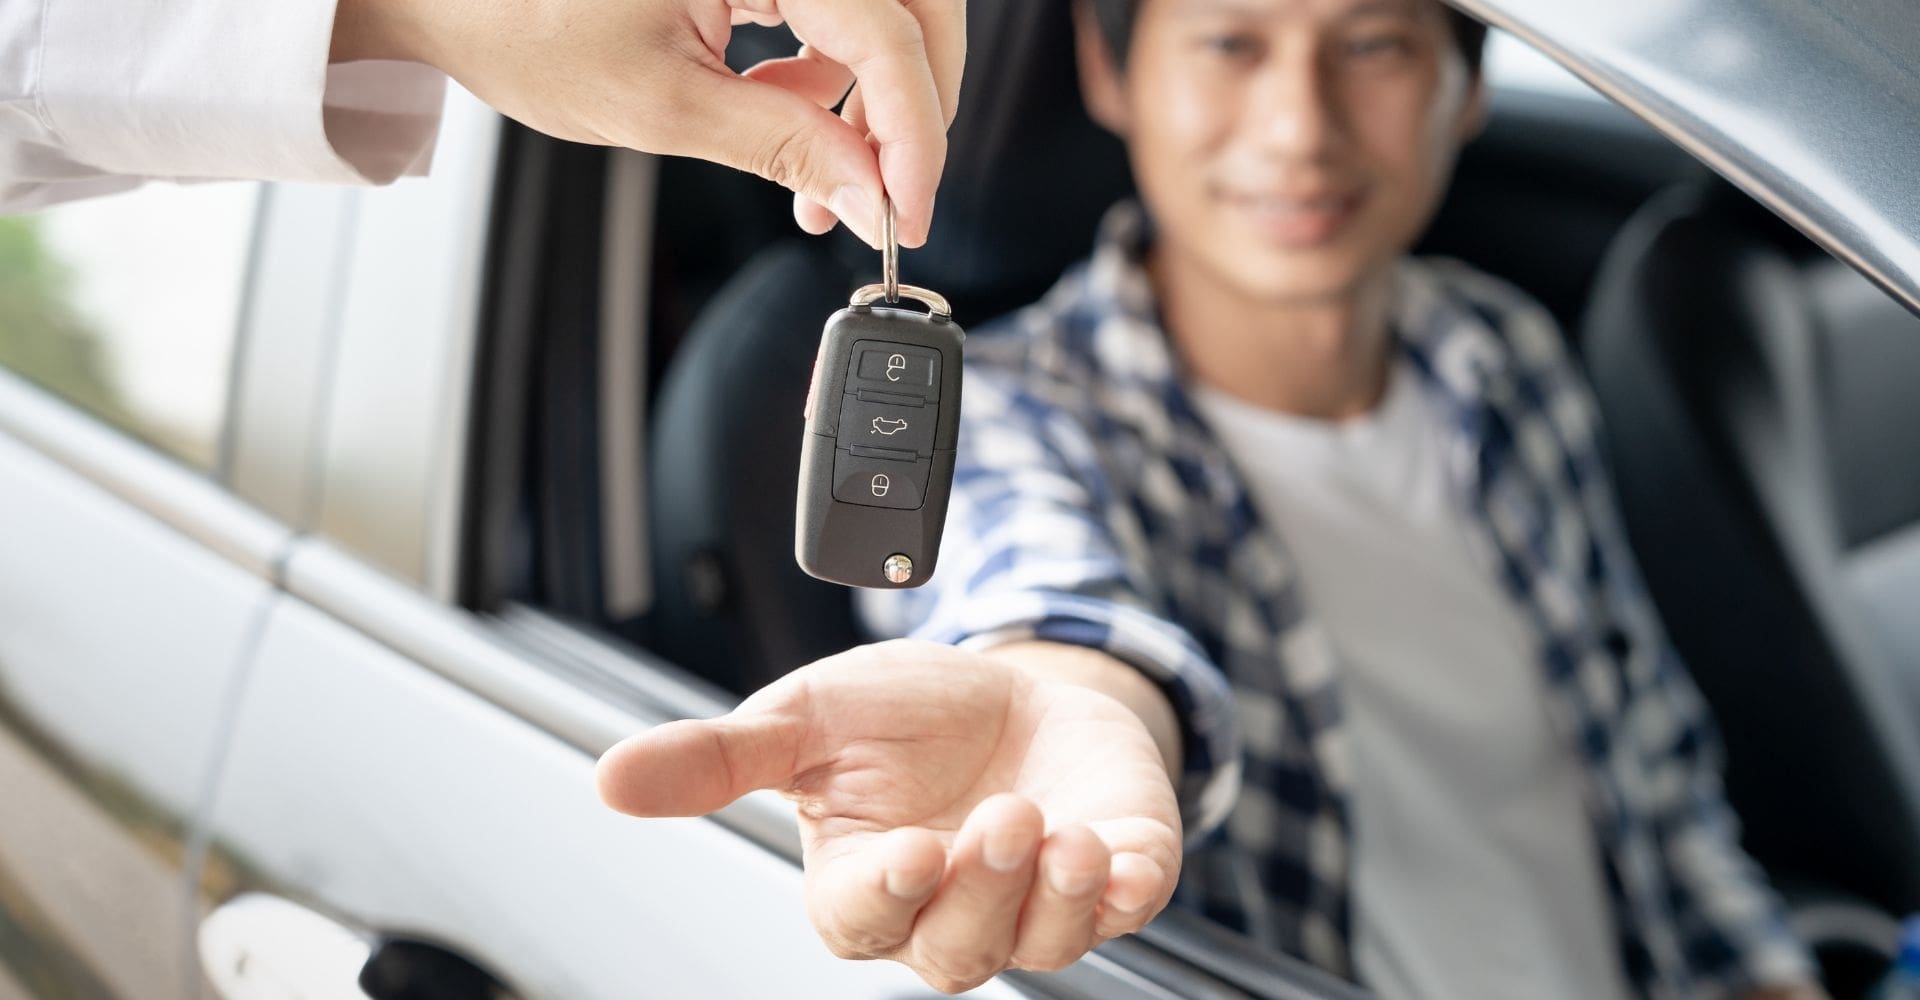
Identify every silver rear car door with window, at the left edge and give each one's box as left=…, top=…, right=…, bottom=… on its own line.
left=0, top=184, right=288, bottom=998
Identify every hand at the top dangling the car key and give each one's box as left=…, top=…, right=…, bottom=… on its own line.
left=332, top=0, right=966, bottom=246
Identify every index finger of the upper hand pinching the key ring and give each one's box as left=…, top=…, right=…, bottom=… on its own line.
left=780, top=0, right=966, bottom=246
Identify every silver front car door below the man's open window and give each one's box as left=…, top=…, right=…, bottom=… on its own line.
left=183, top=94, right=1036, bottom=998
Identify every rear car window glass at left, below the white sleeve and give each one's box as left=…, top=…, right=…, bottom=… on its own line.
left=0, top=184, right=259, bottom=470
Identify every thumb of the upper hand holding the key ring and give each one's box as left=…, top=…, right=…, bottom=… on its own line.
left=672, top=73, right=881, bottom=246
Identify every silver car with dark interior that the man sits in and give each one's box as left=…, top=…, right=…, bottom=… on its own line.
left=0, top=0, right=1920, bottom=1000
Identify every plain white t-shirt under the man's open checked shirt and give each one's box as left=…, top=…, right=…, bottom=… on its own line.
left=1194, top=361, right=1630, bottom=1000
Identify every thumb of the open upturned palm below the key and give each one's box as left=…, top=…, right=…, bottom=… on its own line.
left=593, top=712, right=804, bottom=816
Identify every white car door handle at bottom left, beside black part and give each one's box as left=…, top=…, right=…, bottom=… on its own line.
left=200, top=893, right=372, bottom=1000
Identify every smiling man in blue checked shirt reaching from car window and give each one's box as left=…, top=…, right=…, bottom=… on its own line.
left=601, top=0, right=1822, bottom=1000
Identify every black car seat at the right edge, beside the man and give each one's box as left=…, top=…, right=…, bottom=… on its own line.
left=1582, top=180, right=1920, bottom=963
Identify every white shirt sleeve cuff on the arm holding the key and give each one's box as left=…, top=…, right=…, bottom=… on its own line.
left=0, top=0, right=445, bottom=211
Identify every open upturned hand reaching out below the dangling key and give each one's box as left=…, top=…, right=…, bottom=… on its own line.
left=599, top=641, right=1181, bottom=992
